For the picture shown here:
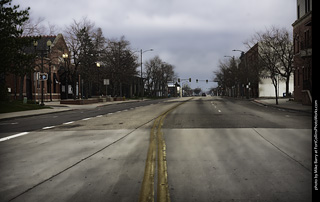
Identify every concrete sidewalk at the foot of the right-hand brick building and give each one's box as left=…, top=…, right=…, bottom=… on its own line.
left=253, top=98, right=312, bottom=114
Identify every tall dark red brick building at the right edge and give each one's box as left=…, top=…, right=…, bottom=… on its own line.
left=292, top=0, right=312, bottom=105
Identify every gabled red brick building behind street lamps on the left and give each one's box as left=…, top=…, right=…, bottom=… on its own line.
left=6, top=34, right=70, bottom=101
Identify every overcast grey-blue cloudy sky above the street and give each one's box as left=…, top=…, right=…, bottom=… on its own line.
left=13, top=0, right=296, bottom=90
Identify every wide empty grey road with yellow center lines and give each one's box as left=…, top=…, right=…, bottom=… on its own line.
left=0, top=97, right=312, bottom=202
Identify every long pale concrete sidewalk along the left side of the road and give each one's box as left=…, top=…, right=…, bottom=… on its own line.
left=0, top=99, right=146, bottom=120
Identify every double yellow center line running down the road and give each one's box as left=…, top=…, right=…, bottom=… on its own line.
left=139, top=99, right=190, bottom=202
